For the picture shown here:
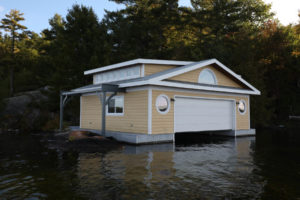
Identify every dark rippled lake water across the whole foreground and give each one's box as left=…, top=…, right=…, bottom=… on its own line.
left=0, top=131, right=300, bottom=200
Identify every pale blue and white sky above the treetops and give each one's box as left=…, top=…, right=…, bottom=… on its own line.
left=0, top=0, right=300, bottom=33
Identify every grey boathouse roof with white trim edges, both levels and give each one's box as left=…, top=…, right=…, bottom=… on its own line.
left=63, top=59, right=260, bottom=95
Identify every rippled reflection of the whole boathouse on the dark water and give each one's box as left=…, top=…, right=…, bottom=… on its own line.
left=77, top=137, right=260, bottom=198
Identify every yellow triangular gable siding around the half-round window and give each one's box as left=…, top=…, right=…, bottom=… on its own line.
left=169, top=66, right=244, bottom=88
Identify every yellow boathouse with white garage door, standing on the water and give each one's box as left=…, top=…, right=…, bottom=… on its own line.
left=61, top=59, right=260, bottom=143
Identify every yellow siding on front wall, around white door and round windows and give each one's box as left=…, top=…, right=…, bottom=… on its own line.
left=152, top=90, right=250, bottom=134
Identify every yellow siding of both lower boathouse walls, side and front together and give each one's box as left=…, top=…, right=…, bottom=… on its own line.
left=81, top=90, right=250, bottom=134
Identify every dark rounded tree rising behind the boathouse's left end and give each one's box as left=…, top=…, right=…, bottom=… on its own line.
left=44, top=5, right=109, bottom=90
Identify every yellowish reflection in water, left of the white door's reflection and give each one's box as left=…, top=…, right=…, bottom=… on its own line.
left=77, top=143, right=175, bottom=199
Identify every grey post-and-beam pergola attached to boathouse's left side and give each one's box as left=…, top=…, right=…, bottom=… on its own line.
left=59, top=84, right=125, bottom=136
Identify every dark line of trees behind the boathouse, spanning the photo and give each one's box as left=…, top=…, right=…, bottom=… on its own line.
left=0, top=0, right=300, bottom=128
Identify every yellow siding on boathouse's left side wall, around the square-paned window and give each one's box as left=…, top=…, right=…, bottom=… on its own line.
left=81, top=91, right=148, bottom=134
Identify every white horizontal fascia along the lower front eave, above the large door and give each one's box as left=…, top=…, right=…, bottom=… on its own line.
left=119, top=81, right=260, bottom=95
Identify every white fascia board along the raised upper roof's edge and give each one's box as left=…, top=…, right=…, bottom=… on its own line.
left=84, top=58, right=193, bottom=75
